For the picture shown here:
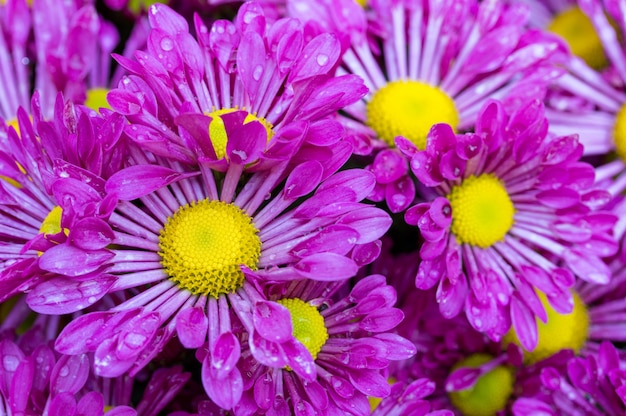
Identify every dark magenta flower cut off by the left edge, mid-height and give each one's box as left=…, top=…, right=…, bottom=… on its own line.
left=0, top=93, right=124, bottom=301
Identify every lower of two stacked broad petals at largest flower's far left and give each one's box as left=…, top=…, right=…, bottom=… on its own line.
left=26, top=275, right=117, bottom=315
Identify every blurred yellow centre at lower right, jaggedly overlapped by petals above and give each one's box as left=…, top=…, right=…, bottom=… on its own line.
left=502, top=292, right=589, bottom=364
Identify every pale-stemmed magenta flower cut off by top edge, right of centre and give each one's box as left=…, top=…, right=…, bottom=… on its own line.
left=288, top=0, right=560, bottom=212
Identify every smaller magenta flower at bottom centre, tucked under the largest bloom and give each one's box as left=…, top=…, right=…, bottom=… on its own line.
left=229, top=275, right=415, bottom=415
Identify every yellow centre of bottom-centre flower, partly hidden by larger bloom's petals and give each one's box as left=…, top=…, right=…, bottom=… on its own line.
left=278, top=298, right=328, bottom=359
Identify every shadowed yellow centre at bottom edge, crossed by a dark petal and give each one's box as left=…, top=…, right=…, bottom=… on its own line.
left=448, top=354, right=515, bottom=416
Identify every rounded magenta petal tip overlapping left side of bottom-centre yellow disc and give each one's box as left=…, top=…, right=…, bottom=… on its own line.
left=252, top=301, right=293, bottom=343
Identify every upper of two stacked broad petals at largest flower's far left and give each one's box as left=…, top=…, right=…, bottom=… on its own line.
left=39, top=244, right=114, bottom=277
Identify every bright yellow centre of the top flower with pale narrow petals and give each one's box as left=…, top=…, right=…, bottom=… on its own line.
left=367, top=80, right=459, bottom=150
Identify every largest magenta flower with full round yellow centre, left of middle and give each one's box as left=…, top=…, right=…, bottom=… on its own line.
left=28, top=111, right=391, bottom=409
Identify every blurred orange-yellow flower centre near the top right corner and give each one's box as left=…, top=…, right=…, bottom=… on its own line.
left=548, top=7, right=608, bottom=69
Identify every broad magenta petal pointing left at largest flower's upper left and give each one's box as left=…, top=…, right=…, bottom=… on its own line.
left=105, top=165, right=193, bottom=201
